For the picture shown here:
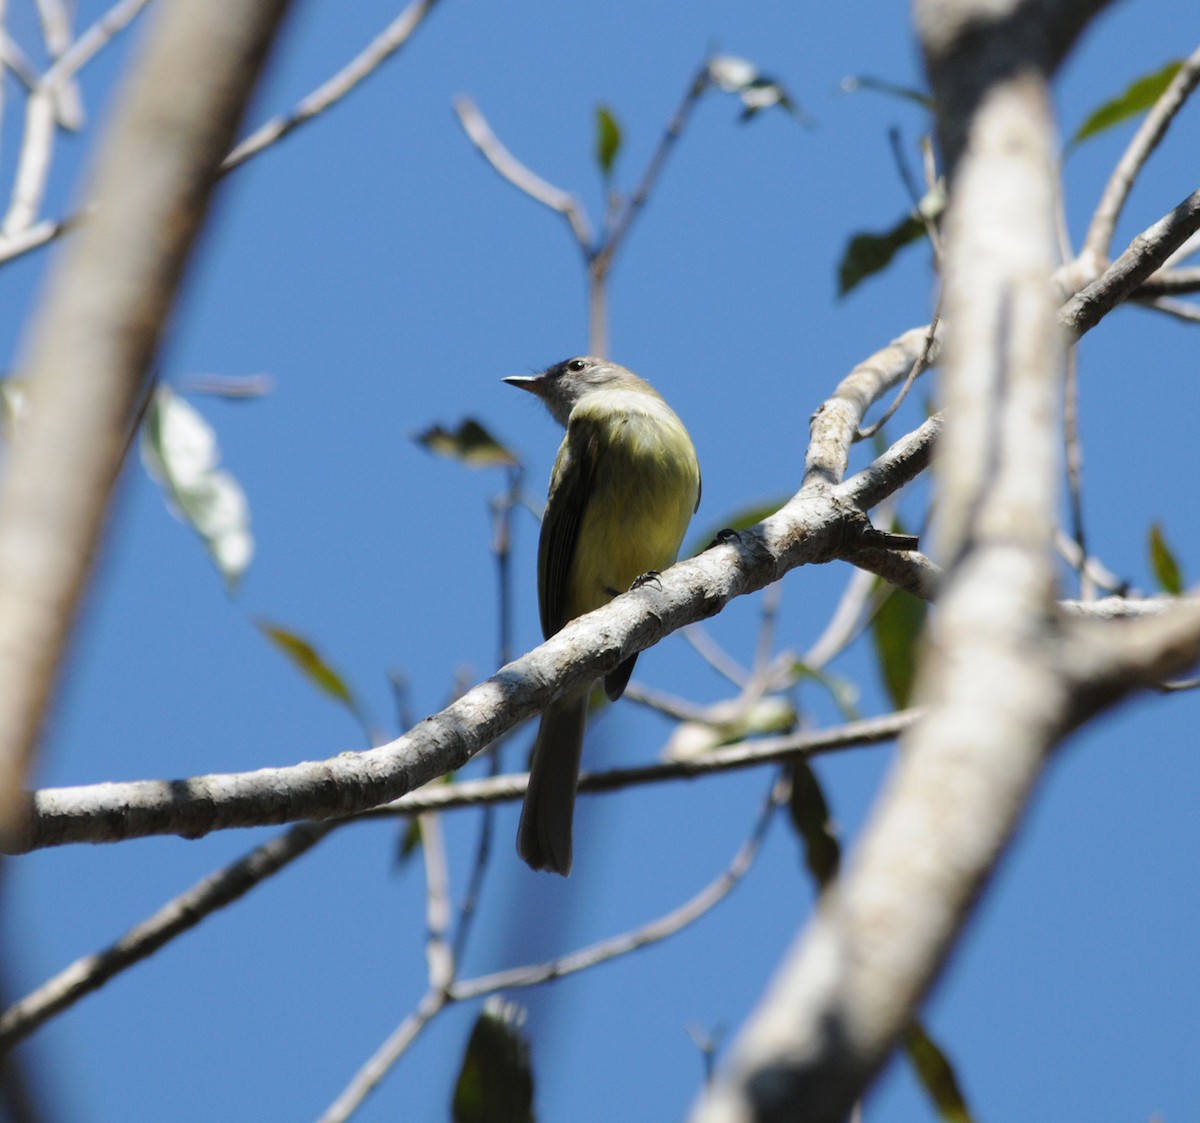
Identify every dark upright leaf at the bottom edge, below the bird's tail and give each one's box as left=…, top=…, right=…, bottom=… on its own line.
left=451, top=995, right=534, bottom=1123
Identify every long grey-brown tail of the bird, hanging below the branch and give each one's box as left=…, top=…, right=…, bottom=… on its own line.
left=517, top=691, right=588, bottom=877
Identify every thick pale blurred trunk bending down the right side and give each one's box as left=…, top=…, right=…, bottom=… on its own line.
left=695, top=0, right=1113, bottom=1123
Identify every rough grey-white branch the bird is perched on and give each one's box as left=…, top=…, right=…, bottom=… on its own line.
left=4, top=488, right=907, bottom=849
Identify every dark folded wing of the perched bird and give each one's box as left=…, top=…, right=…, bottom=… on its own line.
left=538, top=415, right=599, bottom=639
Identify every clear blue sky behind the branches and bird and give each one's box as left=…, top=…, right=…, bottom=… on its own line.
left=0, top=0, right=1200, bottom=1123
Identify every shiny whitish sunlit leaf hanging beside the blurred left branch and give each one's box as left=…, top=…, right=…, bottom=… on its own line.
left=140, top=385, right=254, bottom=590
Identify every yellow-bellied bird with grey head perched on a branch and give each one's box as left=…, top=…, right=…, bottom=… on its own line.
left=504, top=355, right=700, bottom=876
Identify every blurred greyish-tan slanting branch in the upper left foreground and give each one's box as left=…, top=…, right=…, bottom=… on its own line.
left=0, top=0, right=295, bottom=833
